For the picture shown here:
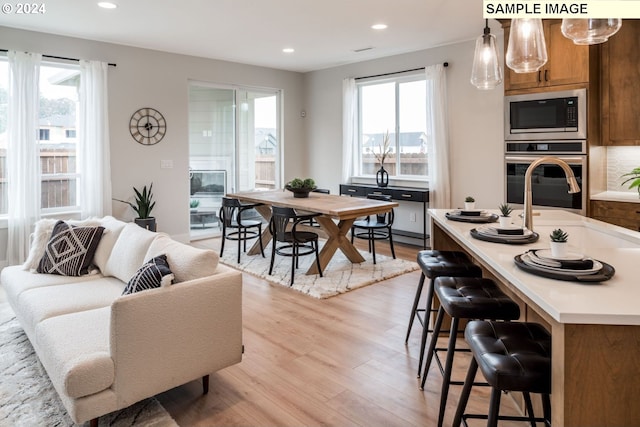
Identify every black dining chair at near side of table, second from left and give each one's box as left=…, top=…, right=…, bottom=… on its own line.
left=269, top=206, right=322, bottom=286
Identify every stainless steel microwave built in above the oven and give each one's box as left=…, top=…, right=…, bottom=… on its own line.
left=504, top=89, right=587, bottom=141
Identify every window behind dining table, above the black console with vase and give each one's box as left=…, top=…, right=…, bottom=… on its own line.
left=358, top=74, right=428, bottom=180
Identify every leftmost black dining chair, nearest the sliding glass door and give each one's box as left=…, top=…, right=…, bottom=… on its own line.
left=218, top=197, right=264, bottom=264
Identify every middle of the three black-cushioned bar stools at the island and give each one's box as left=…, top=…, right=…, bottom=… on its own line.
left=420, top=277, right=520, bottom=427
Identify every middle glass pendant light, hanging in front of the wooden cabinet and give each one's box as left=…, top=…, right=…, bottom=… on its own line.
left=505, top=19, right=547, bottom=73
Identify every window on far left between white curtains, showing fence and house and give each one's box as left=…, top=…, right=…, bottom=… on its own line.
left=0, top=60, right=80, bottom=214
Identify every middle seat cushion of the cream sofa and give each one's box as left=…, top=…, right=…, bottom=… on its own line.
left=17, top=277, right=124, bottom=334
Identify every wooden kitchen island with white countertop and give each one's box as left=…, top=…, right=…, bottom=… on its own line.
left=429, top=209, right=640, bottom=427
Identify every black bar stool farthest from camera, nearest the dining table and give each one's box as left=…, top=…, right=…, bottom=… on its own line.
left=404, top=250, right=482, bottom=378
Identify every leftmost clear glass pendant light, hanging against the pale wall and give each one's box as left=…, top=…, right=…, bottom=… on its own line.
left=471, top=19, right=502, bottom=90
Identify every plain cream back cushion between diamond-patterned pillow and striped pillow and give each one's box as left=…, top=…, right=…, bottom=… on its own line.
left=102, top=222, right=157, bottom=283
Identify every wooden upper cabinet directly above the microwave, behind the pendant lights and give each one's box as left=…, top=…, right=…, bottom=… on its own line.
left=504, top=19, right=589, bottom=92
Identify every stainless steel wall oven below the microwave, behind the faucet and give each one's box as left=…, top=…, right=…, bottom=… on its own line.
left=505, top=141, right=588, bottom=215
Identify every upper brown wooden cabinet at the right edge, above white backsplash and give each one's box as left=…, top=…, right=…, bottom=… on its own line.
left=600, top=19, right=640, bottom=145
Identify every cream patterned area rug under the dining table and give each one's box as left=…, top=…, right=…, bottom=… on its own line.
left=220, top=242, right=418, bottom=299
